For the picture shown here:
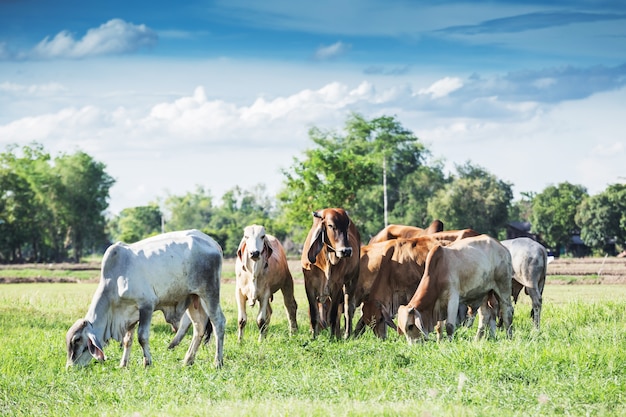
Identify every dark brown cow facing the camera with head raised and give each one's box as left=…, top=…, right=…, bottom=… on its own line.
left=301, top=208, right=361, bottom=338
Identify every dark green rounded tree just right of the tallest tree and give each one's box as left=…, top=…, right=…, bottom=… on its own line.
left=428, top=162, right=513, bottom=237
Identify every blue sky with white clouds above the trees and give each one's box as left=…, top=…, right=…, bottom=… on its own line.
left=0, top=0, right=626, bottom=214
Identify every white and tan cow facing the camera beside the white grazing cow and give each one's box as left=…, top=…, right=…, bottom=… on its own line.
left=235, top=224, right=298, bottom=342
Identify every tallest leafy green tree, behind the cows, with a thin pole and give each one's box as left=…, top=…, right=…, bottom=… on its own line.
left=279, top=113, right=438, bottom=238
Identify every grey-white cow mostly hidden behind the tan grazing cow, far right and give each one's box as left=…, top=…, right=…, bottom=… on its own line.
left=502, top=237, right=548, bottom=330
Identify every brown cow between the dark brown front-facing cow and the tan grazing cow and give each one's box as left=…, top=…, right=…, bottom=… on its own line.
left=355, top=229, right=479, bottom=338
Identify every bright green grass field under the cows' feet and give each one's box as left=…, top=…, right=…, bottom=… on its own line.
left=0, top=284, right=626, bottom=416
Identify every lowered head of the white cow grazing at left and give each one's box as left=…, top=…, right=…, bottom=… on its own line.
left=65, top=319, right=106, bottom=368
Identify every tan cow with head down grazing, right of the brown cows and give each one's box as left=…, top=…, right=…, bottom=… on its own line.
left=398, top=235, right=513, bottom=344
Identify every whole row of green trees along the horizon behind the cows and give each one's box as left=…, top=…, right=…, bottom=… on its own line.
left=0, top=113, right=626, bottom=263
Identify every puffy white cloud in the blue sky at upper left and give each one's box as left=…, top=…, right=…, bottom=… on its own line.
left=31, top=19, right=158, bottom=59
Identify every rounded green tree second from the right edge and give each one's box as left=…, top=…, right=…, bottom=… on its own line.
left=531, top=182, right=588, bottom=252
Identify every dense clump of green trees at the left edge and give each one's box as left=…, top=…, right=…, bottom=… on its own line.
left=0, top=143, right=114, bottom=262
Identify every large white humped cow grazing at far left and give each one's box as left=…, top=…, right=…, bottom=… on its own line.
left=66, top=230, right=226, bottom=367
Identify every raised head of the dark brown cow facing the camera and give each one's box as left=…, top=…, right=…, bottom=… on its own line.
left=307, top=208, right=352, bottom=265
